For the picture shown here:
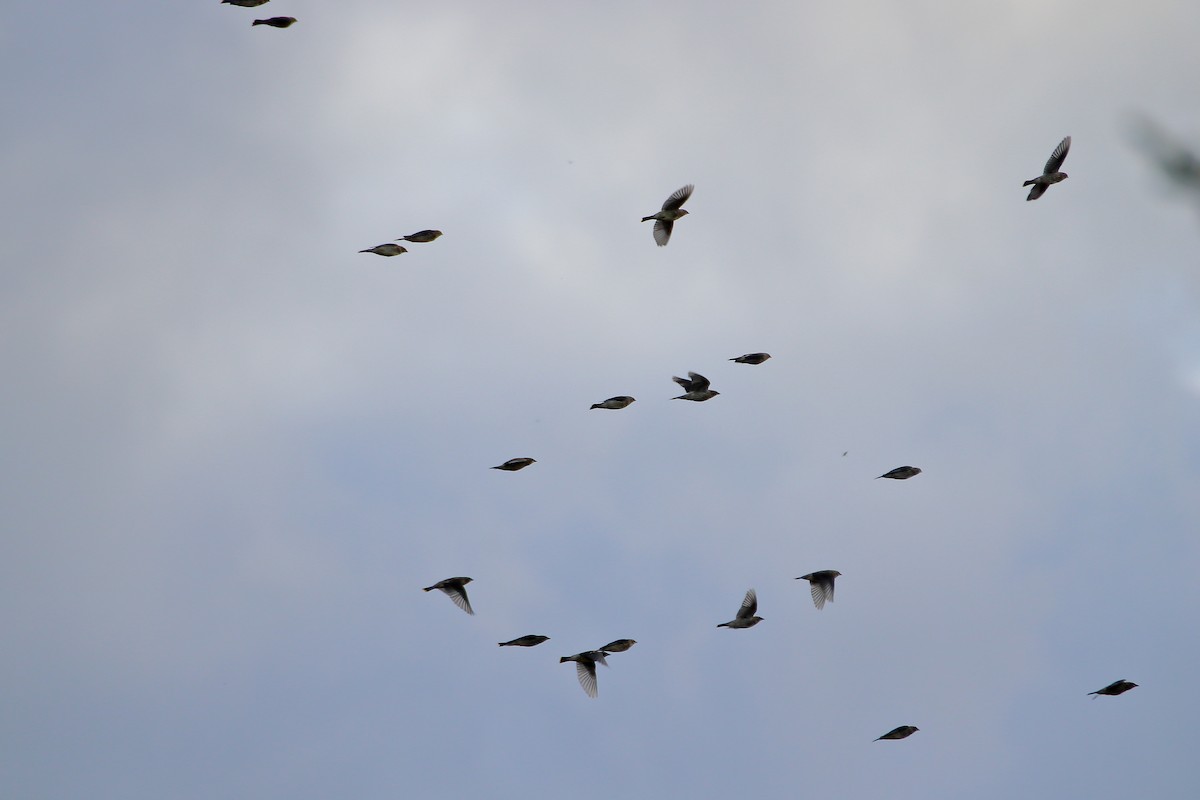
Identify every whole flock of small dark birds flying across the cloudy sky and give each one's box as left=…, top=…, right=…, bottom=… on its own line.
left=221, top=0, right=1138, bottom=741
